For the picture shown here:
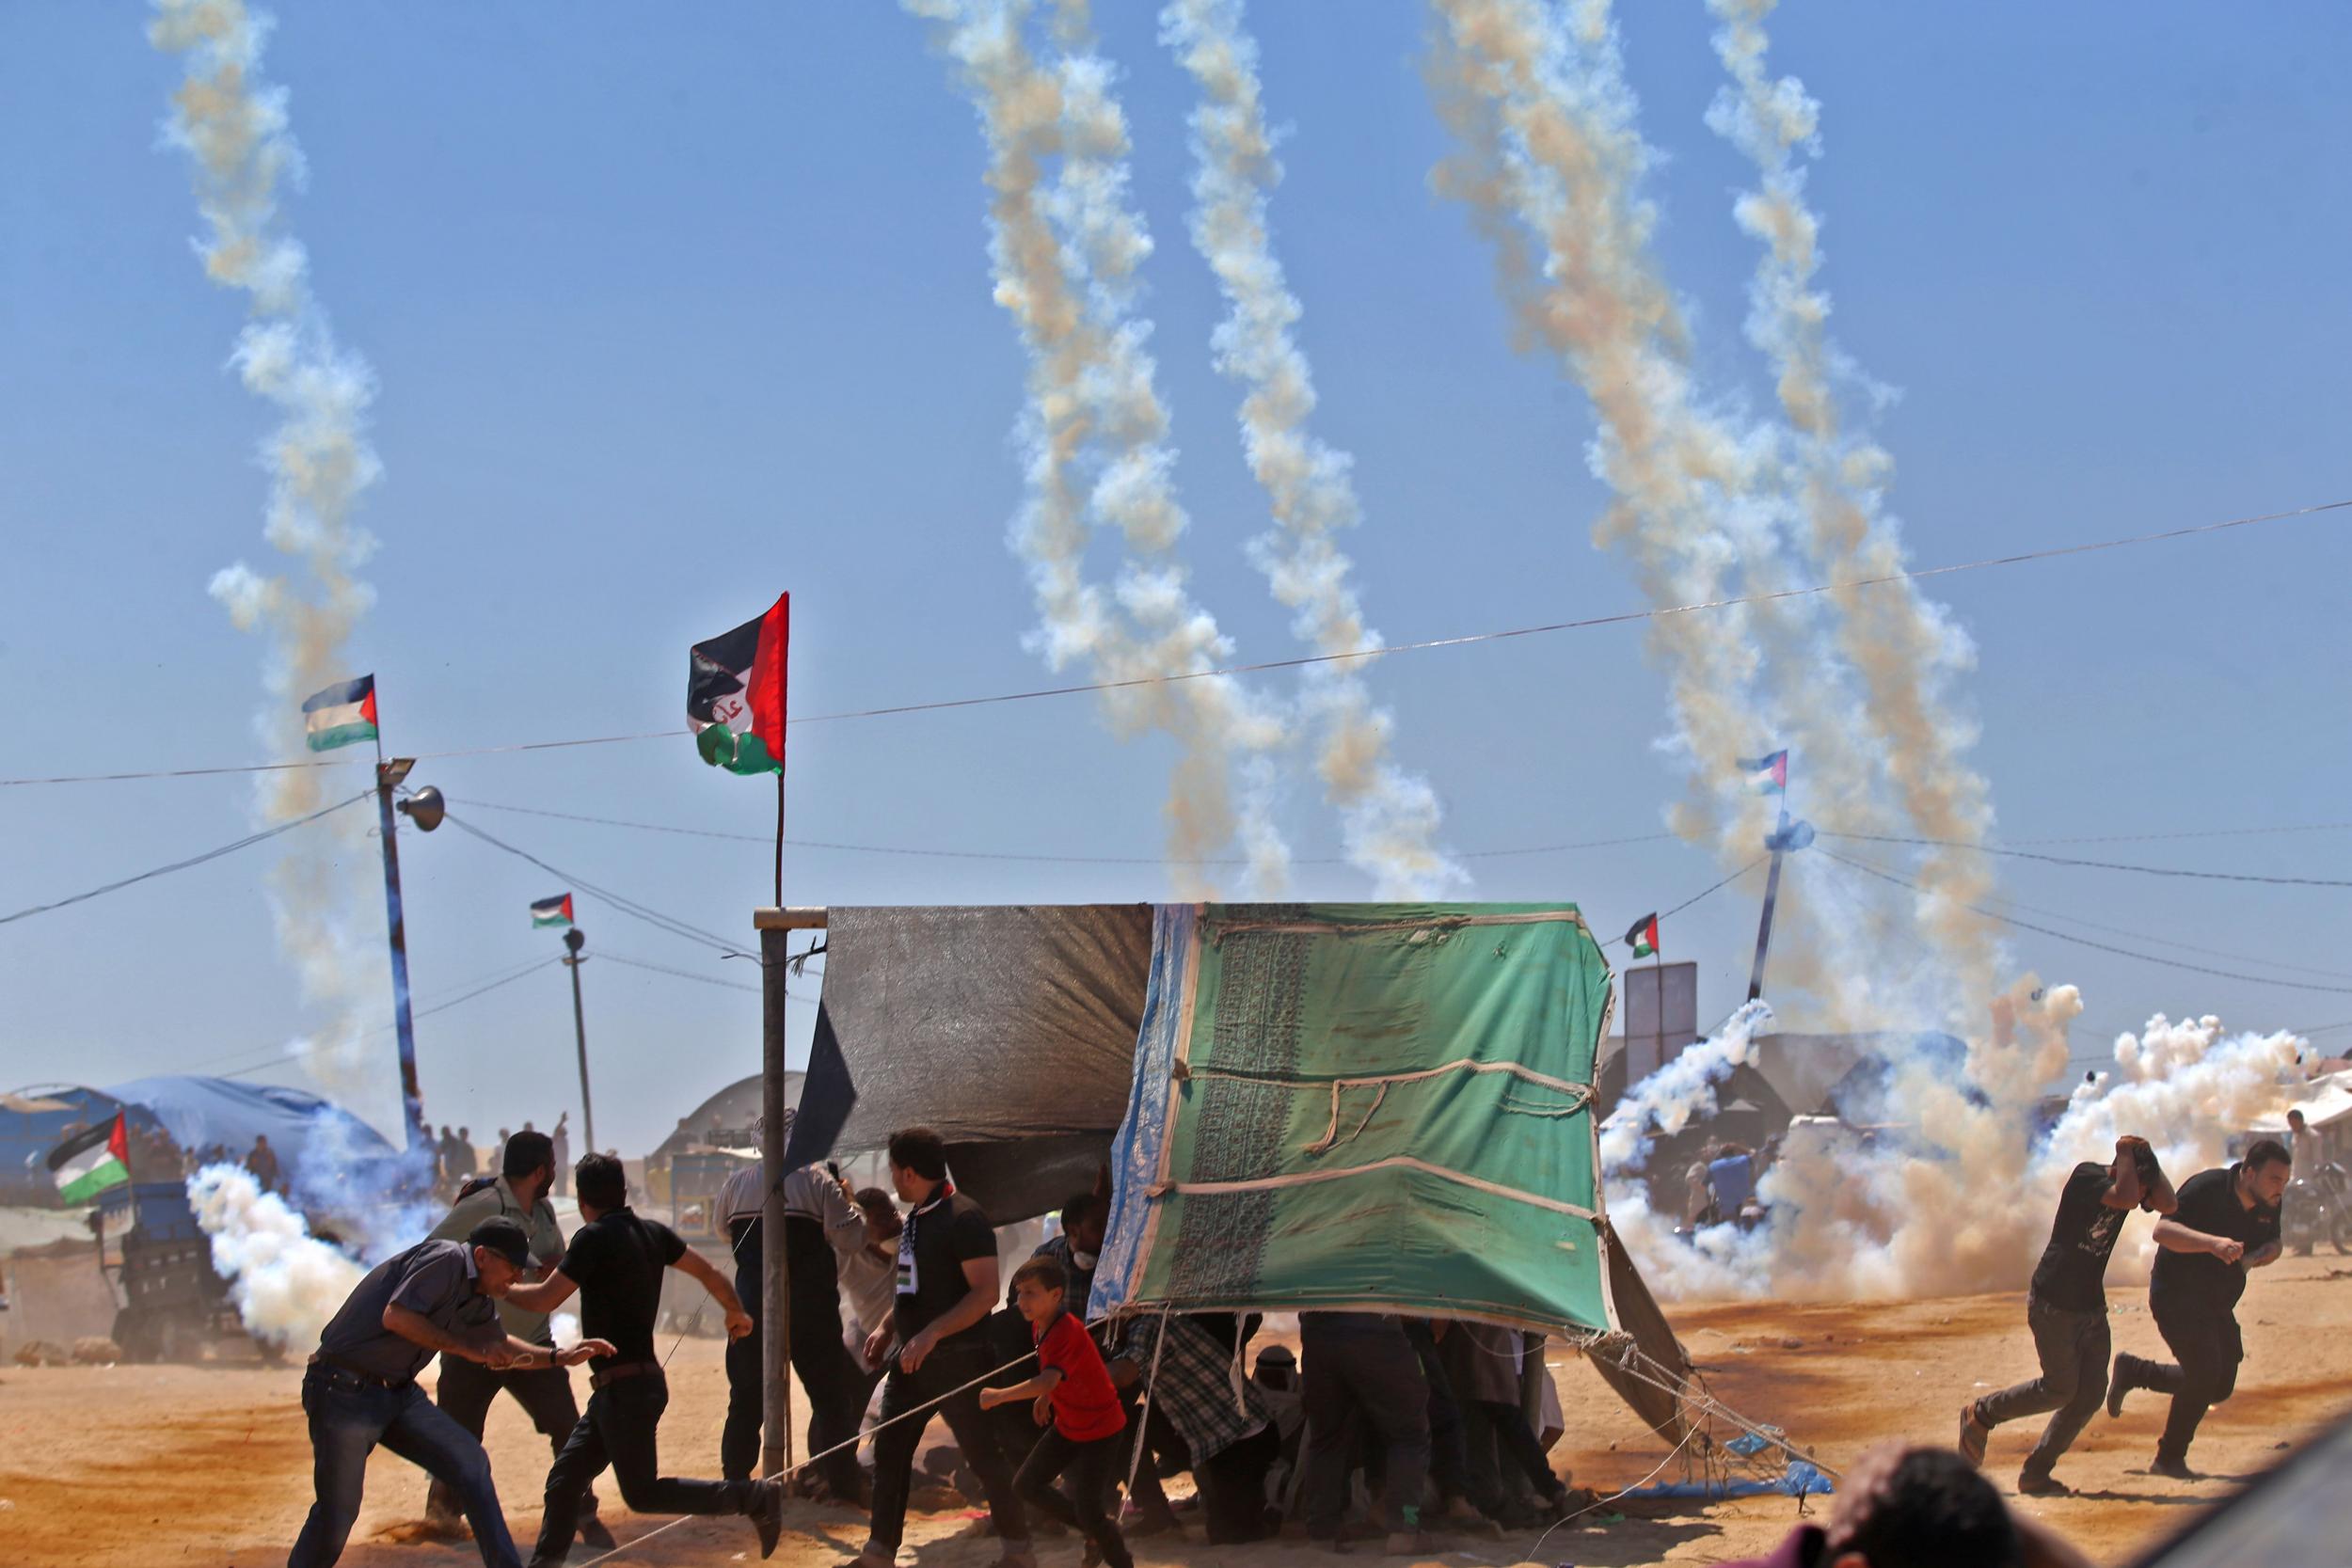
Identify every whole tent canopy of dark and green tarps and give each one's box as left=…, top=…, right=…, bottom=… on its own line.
left=786, top=903, right=1692, bottom=1441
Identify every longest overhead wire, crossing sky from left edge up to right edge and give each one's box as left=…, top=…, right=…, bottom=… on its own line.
left=0, top=499, right=2352, bottom=787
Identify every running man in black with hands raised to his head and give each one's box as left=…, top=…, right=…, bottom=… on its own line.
left=1960, top=1135, right=2178, bottom=1497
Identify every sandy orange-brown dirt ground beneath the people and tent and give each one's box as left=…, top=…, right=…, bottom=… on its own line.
left=0, top=1253, right=2352, bottom=1568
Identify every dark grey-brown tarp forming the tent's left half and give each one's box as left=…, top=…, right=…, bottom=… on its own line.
left=788, top=905, right=1152, bottom=1225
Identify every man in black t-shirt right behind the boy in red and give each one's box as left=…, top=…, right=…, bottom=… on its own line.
left=854, top=1126, right=1038, bottom=1568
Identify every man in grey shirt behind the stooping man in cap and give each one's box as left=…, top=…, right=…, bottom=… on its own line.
left=426, top=1129, right=614, bottom=1552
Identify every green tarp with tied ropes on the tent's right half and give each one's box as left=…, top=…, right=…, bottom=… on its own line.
left=1091, top=903, right=1613, bottom=1333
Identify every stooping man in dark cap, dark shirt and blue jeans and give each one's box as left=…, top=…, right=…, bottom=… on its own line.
left=287, top=1218, right=612, bottom=1568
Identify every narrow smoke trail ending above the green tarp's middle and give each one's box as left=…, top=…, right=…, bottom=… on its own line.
left=1160, top=0, right=1468, bottom=898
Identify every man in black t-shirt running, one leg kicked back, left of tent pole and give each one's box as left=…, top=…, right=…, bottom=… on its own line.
left=506, top=1154, right=784, bottom=1568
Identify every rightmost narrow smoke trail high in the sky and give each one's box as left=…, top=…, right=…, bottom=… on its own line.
left=1708, top=0, right=1997, bottom=997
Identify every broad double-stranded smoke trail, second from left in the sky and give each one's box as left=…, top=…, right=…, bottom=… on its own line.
left=903, top=0, right=1289, bottom=898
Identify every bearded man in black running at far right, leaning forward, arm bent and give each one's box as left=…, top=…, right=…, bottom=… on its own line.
left=2107, top=1138, right=2294, bottom=1481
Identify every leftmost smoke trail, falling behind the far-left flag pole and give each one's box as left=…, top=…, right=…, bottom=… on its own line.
left=149, top=0, right=400, bottom=1124
